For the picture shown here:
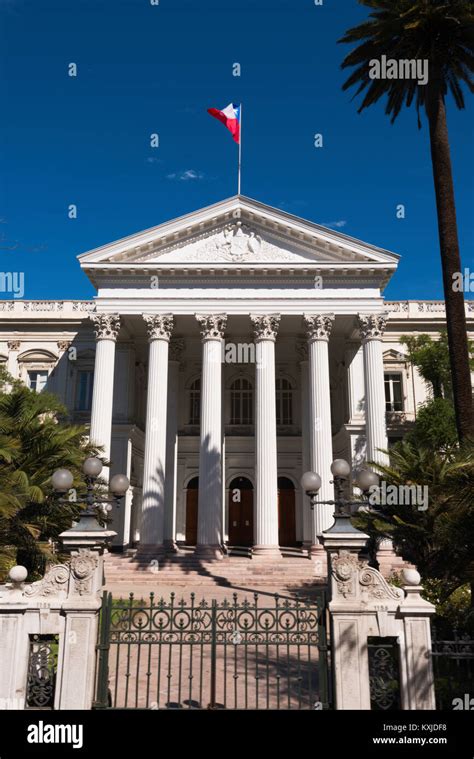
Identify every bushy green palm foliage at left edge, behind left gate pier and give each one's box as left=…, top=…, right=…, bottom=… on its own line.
left=0, top=370, right=103, bottom=576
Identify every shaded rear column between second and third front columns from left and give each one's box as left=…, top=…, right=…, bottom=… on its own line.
left=164, top=339, right=184, bottom=551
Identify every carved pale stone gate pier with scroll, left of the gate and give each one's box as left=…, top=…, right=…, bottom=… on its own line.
left=0, top=517, right=115, bottom=711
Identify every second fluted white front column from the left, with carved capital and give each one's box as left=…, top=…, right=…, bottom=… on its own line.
left=140, top=314, right=173, bottom=554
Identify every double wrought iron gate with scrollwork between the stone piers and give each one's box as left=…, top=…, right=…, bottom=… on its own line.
left=94, top=591, right=330, bottom=709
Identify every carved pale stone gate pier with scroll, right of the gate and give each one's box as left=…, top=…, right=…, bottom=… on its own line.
left=322, top=527, right=435, bottom=709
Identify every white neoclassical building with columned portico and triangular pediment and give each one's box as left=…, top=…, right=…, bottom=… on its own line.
left=0, top=196, right=474, bottom=556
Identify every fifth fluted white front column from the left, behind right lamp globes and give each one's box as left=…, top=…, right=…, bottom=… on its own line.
left=303, top=314, right=334, bottom=574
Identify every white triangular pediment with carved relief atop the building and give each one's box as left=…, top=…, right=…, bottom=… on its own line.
left=79, top=196, right=398, bottom=269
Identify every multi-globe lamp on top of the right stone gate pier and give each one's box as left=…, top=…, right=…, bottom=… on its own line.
left=301, top=459, right=379, bottom=534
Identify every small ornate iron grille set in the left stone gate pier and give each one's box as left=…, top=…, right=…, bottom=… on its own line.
left=25, top=635, right=59, bottom=709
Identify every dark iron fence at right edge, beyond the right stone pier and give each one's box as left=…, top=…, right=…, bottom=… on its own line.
left=431, top=626, right=474, bottom=710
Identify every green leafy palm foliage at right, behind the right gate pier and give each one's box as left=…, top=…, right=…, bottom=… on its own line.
left=355, top=441, right=474, bottom=601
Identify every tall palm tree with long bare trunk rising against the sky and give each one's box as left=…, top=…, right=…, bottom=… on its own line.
left=339, top=0, right=474, bottom=441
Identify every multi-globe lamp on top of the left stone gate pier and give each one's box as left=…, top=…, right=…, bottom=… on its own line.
left=51, top=456, right=130, bottom=531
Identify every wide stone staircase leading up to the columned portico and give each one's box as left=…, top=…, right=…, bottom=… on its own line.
left=104, top=549, right=324, bottom=591
